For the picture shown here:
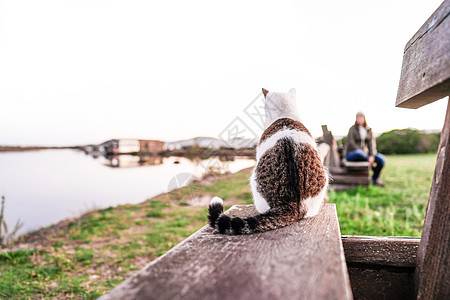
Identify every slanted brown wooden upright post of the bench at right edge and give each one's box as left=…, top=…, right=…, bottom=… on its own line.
left=416, top=100, right=450, bottom=299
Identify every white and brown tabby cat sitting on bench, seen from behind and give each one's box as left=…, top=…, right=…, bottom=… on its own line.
left=208, top=89, right=328, bottom=234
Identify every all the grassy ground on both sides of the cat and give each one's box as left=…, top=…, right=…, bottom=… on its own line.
left=0, top=155, right=436, bottom=299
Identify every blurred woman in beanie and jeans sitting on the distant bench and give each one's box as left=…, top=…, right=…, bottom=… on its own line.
left=345, top=112, right=386, bottom=186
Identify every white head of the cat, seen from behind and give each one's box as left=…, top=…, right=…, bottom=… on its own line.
left=262, top=88, right=300, bottom=127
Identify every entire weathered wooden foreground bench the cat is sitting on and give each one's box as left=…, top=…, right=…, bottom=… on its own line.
left=101, top=0, right=450, bottom=300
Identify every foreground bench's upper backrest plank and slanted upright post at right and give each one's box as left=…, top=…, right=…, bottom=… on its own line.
left=396, top=0, right=450, bottom=299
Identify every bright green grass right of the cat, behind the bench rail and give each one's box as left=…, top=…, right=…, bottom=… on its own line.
left=329, top=154, right=436, bottom=236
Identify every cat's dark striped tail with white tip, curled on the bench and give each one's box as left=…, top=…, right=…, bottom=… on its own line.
left=208, top=197, right=299, bottom=234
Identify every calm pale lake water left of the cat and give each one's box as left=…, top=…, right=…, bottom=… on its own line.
left=0, top=150, right=255, bottom=232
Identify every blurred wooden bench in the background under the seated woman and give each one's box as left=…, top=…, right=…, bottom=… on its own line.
left=322, top=125, right=370, bottom=191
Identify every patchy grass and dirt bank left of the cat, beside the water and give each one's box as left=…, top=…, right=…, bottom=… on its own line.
left=0, top=168, right=251, bottom=299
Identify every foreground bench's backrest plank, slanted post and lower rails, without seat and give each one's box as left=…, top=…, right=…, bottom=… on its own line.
left=342, top=0, right=450, bottom=299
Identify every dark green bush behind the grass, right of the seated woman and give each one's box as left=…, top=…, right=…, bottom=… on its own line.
left=376, top=129, right=439, bottom=154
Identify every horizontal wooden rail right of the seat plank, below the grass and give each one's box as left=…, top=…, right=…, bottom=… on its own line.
left=342, top=235, right=420, bottom=268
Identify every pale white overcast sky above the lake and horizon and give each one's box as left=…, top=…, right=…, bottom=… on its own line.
left=0, top=0, right=447, bottom=145
